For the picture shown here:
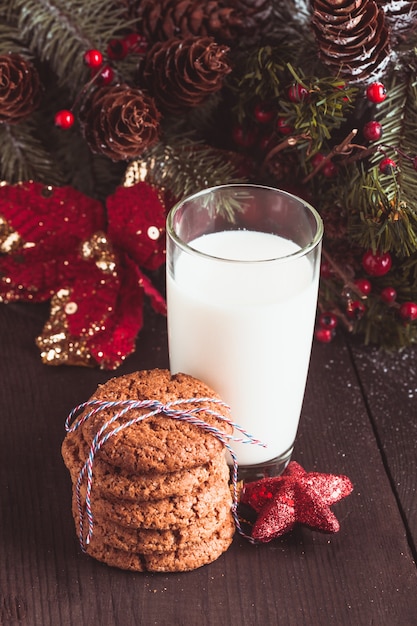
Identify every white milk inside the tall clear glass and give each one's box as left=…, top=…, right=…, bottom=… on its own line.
left=167, top=231, right=318, bottom=465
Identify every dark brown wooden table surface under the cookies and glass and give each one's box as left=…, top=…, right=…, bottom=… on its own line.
left=0, top=304, right=417, bottom=626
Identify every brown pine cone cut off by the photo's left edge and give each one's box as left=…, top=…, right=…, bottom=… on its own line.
left=0, top=54, right=41, bottom=124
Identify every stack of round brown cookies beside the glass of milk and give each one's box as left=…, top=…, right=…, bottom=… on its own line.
left=62, top=370, right=235, bottom=572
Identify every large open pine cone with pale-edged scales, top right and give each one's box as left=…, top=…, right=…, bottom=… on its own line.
left=311, top=0, right=390, bottom=82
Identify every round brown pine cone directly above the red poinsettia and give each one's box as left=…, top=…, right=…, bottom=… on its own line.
left=80, top=84, right=160, bottom=161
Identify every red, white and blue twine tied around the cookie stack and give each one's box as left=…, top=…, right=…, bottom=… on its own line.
left=65, top=398, right=266, bottom=552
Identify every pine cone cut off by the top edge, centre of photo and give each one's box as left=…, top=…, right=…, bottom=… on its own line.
left=137, top=0, right=245, bottom=43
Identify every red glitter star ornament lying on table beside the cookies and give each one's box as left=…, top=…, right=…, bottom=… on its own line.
left=240, top=461, right=353, bottom=543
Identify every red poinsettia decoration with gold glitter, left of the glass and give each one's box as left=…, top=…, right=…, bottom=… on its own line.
left=0, top=182, right=169, bottom=369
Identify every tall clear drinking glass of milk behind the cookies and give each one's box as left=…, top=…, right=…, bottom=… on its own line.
left=167, top=184, right=323, bottom=480
